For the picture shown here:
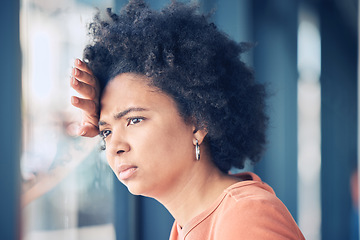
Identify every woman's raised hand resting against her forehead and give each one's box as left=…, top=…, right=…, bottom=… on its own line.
left=70, top=59, right=100, bottom=137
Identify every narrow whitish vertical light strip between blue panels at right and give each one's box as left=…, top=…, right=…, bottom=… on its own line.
left=298, top=5, right=321, bottom=240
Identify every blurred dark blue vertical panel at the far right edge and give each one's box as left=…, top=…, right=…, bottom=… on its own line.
left=319, top=2, right=357, bottom=240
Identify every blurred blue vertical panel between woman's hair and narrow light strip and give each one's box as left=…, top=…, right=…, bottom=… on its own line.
left=253, top=0, right=298, bottom=219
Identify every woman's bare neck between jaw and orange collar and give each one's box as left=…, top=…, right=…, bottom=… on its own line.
left=156, top=152, right=239, bottom=227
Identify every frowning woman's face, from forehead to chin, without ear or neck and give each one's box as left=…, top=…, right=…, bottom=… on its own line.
left=99, top=73, right=196, bottom=198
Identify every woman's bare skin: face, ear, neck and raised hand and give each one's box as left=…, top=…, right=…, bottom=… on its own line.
left=70, top=60, right=239, bottom=226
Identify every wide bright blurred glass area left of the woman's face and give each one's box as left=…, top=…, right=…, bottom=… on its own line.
left=20, top=0, right=115, bottom=240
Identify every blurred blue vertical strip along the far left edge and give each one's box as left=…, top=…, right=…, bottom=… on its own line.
left=0, top=0, right=21, bottom=239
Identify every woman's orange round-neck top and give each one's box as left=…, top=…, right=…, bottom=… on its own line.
left=170, top=172, right=305, bottom=240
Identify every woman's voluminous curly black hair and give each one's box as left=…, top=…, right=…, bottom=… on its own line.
left=84, top=0, right=268, bottom=173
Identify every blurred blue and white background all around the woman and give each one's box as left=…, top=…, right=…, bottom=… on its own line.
left=0, top=0, right=359, bottom=240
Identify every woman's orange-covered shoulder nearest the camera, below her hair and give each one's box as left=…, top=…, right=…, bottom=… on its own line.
left=212, top=174, right=303, bottom=240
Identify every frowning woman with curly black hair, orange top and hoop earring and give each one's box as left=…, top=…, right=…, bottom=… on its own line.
left=71, top=0, right=304, bottom=240
